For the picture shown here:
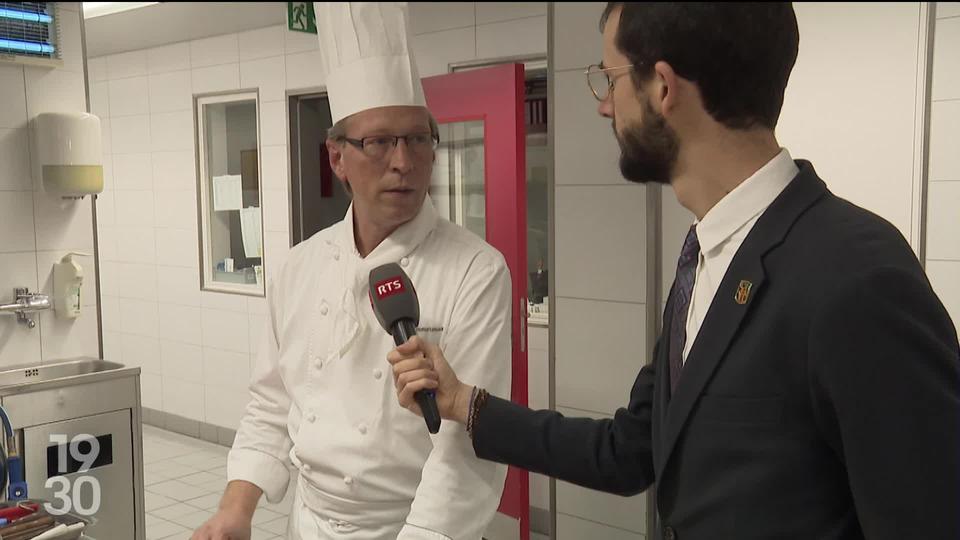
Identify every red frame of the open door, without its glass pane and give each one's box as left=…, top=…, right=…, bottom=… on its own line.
left=423, top=64, right=530, bottom=540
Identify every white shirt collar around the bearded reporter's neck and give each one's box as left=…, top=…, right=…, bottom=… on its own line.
left=697, top=148, right=799, bottom=255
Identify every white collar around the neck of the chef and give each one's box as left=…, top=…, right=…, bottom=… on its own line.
left=337, top=195, right=438, bottom=266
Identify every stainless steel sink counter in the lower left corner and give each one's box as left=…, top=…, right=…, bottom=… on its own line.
left=0, top=358, right=146, bottom=540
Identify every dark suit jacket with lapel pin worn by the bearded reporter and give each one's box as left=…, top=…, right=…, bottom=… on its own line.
left=474, top=161, right=960, bottom=540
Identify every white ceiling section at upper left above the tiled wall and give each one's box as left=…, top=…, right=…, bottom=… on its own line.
left=84, top=2, right=287, bottom=58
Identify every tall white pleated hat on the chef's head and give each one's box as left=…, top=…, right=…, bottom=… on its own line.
left=313, top=2, right=426, bottom=123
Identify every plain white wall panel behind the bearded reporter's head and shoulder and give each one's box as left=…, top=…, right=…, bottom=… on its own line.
left=776, top=2, right=928, bottom=243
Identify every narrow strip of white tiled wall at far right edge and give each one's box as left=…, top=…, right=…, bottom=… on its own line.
left=926, top=7, right=960, bottom=338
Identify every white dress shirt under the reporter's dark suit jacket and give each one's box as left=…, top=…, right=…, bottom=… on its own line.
left=683, top=148, right=800, bottom=362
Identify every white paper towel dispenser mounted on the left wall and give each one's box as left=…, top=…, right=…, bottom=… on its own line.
left=31, top=113, right=103, bottom=198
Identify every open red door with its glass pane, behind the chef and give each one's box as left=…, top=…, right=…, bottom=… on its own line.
left=423, top=64, right=530, bottom=540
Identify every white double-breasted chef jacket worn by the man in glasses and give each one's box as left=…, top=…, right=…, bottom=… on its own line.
left=227, top=197, right=511, bottom=540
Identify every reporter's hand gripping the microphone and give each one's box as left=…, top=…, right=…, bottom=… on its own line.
left=387, top=336, right=473, bottom=424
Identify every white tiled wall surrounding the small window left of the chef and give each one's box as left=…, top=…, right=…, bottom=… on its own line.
left=90, top=27, right=296, bottom=429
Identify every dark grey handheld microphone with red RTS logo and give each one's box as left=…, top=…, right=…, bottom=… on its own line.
left=368, top=263, right=440, bottom=433
